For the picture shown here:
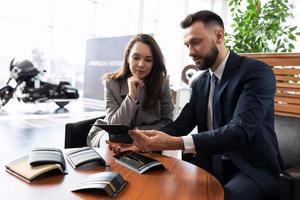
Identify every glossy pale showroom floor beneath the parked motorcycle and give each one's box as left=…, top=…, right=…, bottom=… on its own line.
left=0, top=99, right=105, bottom=159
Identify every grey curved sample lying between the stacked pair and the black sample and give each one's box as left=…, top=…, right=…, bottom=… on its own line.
left=66, top=147, right=107, bottom=168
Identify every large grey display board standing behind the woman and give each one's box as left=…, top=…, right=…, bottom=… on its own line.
left=83, top=35, right=132, bottom=100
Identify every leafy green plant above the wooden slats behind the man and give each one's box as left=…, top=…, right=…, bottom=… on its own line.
left=226, top=0, right=300, bottom=53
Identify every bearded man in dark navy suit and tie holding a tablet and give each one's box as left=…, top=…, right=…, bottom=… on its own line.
left=106, top=11, right=282, bottom=200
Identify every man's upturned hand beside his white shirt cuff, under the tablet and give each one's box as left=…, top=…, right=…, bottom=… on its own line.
left=128, top=130, right=184, bottom=151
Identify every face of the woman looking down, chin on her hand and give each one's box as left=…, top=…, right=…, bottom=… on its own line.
left=128, top=42, right=153, bottom=80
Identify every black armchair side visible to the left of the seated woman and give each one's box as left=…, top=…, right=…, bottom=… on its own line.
left=65, top=116, right=105, bottom=148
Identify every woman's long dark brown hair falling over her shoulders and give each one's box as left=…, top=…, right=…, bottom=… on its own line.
left=103, top=34, right=167, bottom=110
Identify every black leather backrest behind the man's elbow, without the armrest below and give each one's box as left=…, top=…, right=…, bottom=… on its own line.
left=275, top=116, right=300, bottom=169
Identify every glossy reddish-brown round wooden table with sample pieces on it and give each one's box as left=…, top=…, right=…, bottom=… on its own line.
left=0, top=147, right=224, bottom=200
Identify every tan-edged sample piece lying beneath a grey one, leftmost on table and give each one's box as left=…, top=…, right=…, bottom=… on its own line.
left=5, top=156, right=65, bottom=182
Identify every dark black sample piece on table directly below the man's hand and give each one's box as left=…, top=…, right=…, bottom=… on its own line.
left=113, top=151, right=165, bottom=174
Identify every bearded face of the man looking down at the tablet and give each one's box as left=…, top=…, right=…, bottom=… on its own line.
left=184, top=22, right=219, bottom=70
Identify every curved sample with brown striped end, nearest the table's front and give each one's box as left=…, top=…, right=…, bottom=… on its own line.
left=72, top=172, right=127, bottom=197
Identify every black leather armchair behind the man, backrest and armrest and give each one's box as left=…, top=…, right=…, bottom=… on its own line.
left=275, top=116, right=300, bottom=200
